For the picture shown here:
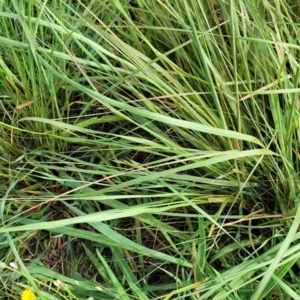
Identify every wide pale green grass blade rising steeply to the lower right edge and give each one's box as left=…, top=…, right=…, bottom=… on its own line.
left=251, top=204, right=300, bottom=300
